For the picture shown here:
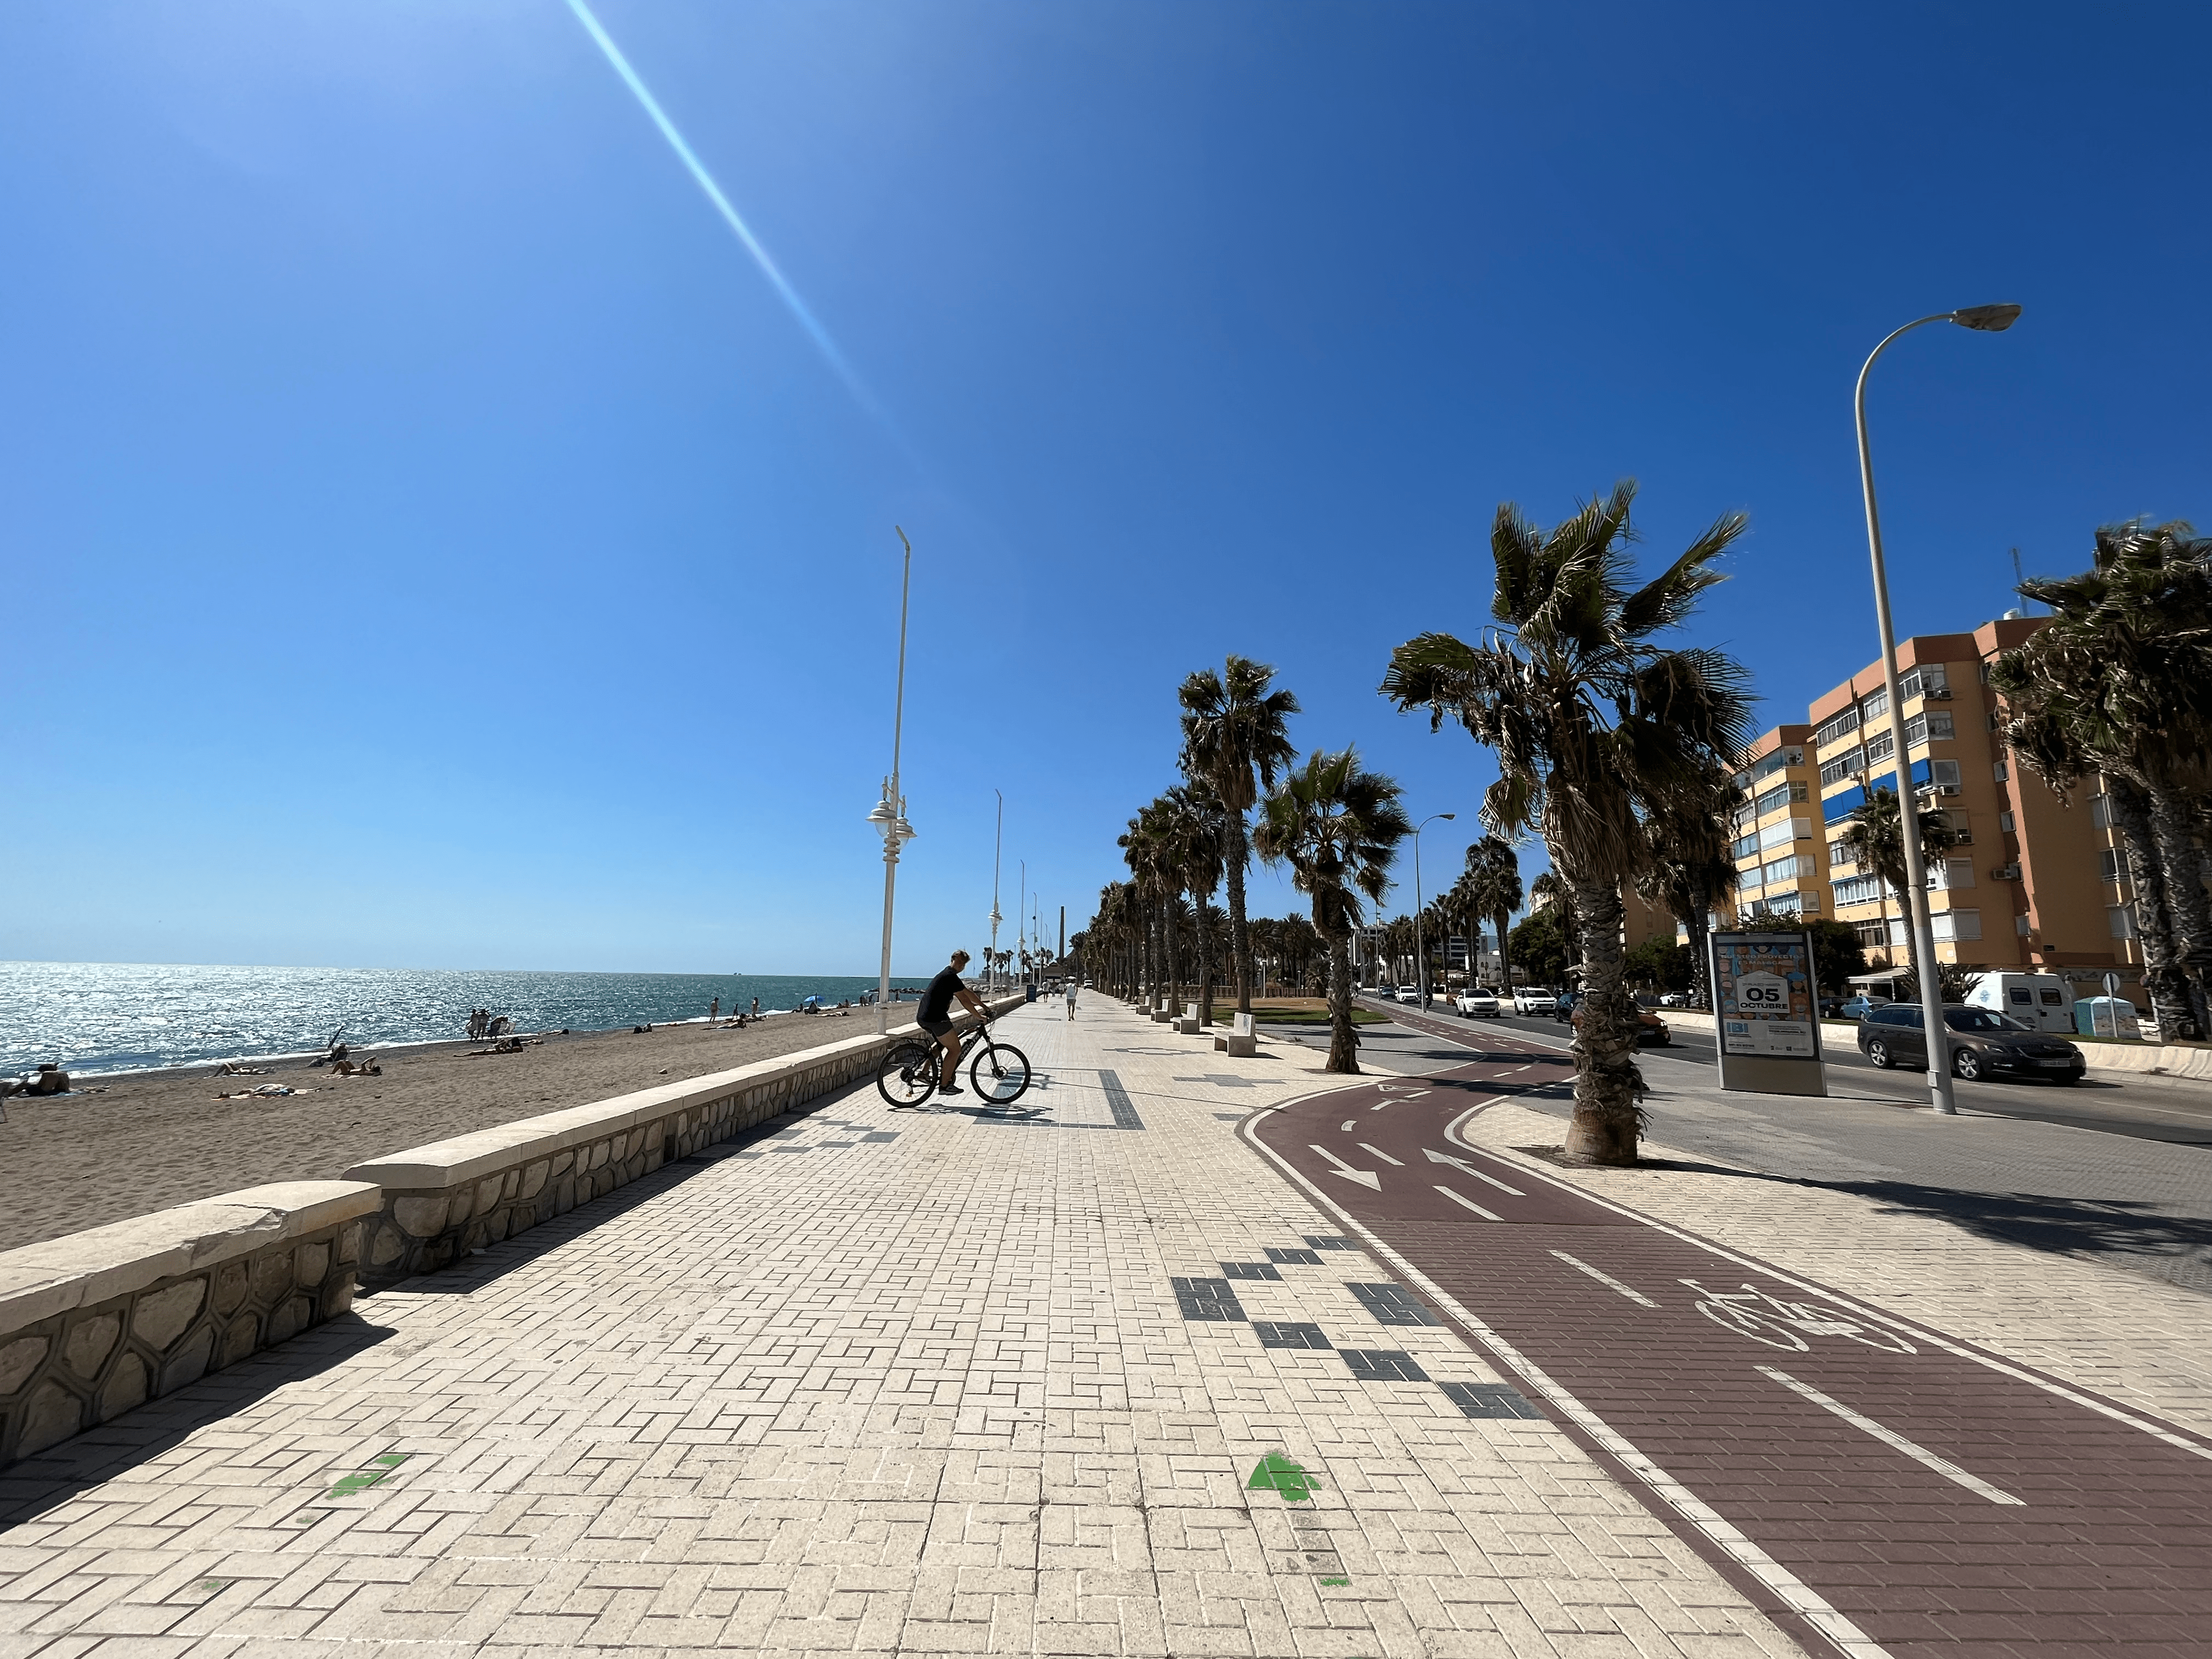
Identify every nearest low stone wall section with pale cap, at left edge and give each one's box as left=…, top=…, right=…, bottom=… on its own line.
left=0, top=1181, right=378, bottom=1464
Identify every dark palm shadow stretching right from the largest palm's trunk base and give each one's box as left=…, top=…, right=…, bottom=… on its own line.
left=1637, top=1157, right=2212, bottom=1278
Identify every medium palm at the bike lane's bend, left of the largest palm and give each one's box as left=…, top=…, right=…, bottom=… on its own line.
left=1254, top=748, right=1413, bottom=1075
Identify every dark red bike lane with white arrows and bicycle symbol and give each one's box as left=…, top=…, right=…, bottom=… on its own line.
left=1248, top=1033, right=2212, bottom=1659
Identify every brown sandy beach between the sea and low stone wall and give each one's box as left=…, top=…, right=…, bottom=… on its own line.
left=0, top=1005, right=913, bottom=1250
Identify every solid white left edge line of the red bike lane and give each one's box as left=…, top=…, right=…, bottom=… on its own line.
left=1237, top=1119, right=1891, bottom=1659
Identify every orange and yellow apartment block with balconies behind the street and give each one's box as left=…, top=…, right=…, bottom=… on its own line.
left=1732, top=617, right=2141, bottom=989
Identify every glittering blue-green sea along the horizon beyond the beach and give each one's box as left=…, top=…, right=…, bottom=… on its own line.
left=0, top=962, right=922, bottom=1075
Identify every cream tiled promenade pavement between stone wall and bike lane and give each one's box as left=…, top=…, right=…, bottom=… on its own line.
left=0, top=997, right=1792, bottom=1659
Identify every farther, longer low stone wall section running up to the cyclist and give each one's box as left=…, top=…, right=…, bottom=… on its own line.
left=345, top=997, right=1022, bottom=1290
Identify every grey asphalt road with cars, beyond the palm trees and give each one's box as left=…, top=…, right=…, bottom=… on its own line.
left=1267, top=1002, right=2212, bottom=1148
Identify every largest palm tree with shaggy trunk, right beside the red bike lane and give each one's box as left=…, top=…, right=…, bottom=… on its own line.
left=1383, top=482, right=1750, bottom=1164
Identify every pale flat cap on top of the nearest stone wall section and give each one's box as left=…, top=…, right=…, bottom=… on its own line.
left=0, top=1181, right=383, bottom=1336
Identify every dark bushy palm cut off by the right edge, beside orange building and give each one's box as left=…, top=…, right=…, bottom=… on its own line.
left=1989, top=522, right=2212, bottom=1035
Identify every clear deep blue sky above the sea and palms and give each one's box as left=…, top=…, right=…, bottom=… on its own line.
left=0, top=0, right=2212, bottom=971
